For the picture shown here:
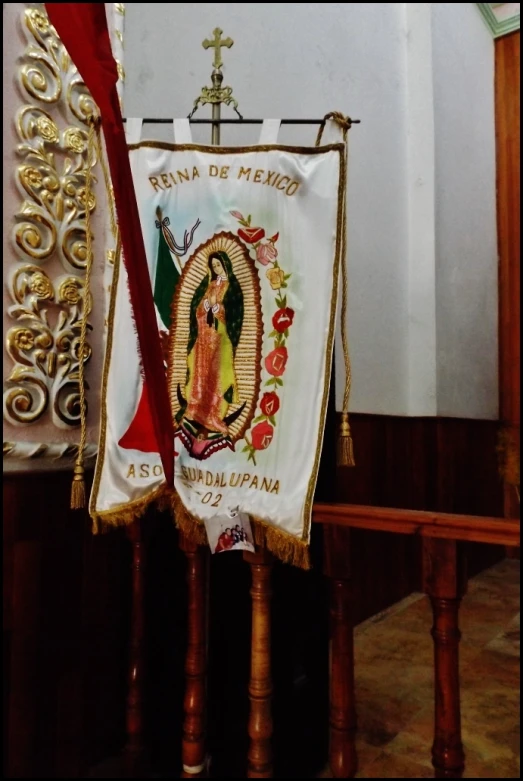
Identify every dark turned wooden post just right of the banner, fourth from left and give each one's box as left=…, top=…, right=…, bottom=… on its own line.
left=323, top=525, right=358, bottom=778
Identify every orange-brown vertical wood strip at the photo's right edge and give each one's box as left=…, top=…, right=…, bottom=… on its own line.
left=495, top=31, right=521, bottom=517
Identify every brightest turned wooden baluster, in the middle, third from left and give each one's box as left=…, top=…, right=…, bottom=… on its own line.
left=243, top=550, right=273, bottom=778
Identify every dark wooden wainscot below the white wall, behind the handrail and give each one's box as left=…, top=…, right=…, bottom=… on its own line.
left=336, top=414, right=504, bottom=624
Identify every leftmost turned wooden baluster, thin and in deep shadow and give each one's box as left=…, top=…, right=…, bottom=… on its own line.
left=124, top=520, right=145, bottom=778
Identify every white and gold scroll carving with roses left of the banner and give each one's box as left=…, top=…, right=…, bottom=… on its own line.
left=4, top=4, right=123, bottom=428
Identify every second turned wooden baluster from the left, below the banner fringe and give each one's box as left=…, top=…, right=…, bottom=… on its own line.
left=180, top=533, right=207, bottom=778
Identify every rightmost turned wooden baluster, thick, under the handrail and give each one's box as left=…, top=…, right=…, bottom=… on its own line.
left=423, top=539, right=466, bottom=778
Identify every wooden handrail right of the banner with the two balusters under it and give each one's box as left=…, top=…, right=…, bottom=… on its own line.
left=313, top=504, right=520, bottom=778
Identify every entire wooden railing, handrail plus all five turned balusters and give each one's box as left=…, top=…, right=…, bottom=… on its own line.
left=127, top=504, right=520, bottom=778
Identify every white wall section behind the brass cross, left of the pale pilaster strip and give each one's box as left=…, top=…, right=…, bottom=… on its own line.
left=125, top=3, right=409, bottom=415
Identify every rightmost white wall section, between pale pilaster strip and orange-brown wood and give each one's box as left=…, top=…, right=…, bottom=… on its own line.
left=432, top=3, right=498, bottom=419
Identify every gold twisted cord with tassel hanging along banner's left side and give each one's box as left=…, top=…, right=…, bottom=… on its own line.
left=71, top=117, right=97, bottom=510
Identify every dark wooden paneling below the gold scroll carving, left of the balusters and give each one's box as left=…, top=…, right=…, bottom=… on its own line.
left=3, top=473, right=130, bottom=778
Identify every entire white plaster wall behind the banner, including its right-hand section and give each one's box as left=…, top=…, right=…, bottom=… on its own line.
left=125, top=3, right=497, bottom=418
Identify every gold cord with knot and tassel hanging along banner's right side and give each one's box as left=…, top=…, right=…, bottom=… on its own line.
left=316, top=111, right=355, bottom=466
